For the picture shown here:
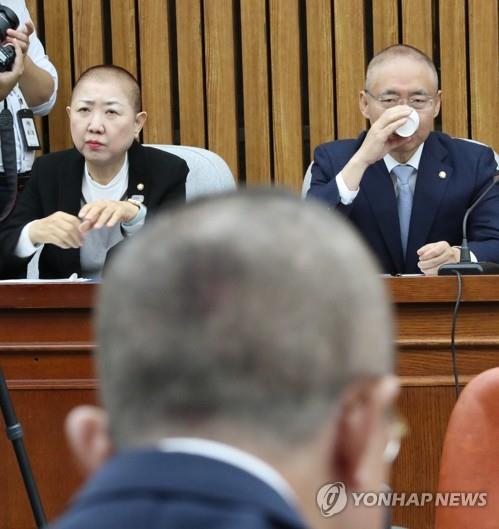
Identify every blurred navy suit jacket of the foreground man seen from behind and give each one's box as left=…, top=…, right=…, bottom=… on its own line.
left=52, top=450, right=313, bottom=529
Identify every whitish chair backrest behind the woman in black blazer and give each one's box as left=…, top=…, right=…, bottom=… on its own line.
left=148, top=144, right=236, bottom=201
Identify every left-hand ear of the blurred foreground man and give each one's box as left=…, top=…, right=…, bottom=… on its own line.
left=66, top=406, right=112, bottom=476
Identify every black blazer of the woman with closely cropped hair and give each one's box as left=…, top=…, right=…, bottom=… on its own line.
left=0, top=142, right=189, bottom=279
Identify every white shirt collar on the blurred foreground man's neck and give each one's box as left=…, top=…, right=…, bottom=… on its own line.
left=158, top=437, right=296, bottom=505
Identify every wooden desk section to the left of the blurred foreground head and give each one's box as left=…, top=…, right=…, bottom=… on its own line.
left=0, top=284, right=96, bottom=529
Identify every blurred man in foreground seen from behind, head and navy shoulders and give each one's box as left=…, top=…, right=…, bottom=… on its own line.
left=52, top=191, right=397, bottom=529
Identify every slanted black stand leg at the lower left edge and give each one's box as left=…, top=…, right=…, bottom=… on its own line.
left=0, top=368, right=47, bottom=529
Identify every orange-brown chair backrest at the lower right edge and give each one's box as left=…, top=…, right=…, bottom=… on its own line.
left=435, top=368, right=499, bottom=529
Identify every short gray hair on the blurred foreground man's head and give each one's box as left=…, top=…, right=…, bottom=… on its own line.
left=97, top=190, right=392, bottom=447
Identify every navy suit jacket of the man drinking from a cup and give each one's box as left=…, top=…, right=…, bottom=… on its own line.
left=308, top=132, right=499, bottom=274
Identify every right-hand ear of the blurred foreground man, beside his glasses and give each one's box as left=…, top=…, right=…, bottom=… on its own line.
left=331, top=376, right=399, bottom=490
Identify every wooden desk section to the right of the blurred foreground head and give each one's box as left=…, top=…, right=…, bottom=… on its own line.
left=387, top=276, right=499, bottom=529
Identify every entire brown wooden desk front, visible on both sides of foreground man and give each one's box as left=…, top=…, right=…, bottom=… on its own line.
left=0, top=276, right=499, bottom=529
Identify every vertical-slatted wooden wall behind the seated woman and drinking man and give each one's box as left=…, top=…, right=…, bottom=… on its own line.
left=27, top=0, right=499, bottom=190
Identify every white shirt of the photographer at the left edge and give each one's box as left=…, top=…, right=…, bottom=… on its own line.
left=0, top=0, right=57, bottom=173
